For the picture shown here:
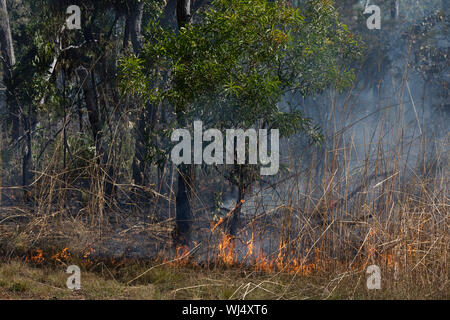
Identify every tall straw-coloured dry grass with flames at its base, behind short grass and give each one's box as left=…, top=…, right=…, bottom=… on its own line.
left=0, top=50, right=450, bottom=296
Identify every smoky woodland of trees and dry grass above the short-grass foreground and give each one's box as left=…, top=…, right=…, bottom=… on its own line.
left=0, top=0, right=450, bottom=300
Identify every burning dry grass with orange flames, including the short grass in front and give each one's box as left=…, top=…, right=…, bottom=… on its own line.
left=0, top=82, right=450, bottom=299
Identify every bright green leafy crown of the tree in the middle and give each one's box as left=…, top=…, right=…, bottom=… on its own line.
left=121, top=0, right=360, bottom=141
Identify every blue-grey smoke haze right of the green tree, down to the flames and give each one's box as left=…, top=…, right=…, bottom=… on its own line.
left=209, top=1, right=450, bottom=255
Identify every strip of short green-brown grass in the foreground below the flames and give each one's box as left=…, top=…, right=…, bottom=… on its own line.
left=0, top=260, right=450, bottom=300
